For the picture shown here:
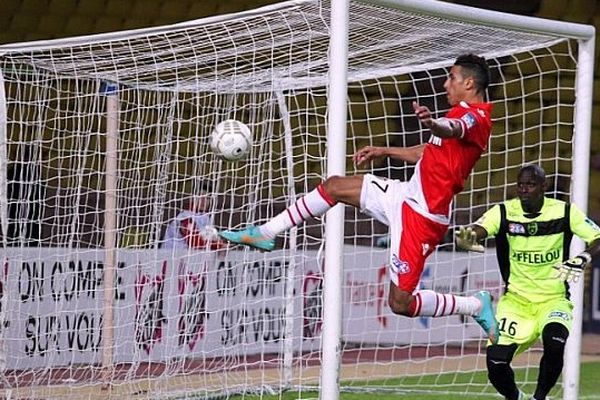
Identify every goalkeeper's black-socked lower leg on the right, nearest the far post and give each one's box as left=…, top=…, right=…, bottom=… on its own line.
left=533, top=322, right=569, bottom=400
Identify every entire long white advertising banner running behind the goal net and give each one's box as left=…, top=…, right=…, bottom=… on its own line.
left=0, top=246, right=501, bottom=369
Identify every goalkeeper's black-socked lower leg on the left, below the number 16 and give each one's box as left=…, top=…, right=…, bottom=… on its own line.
left=486, top=344, right=520, bottom=400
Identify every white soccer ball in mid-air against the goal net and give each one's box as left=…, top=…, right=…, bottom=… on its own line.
left=210, top=119, right=252, bottom=161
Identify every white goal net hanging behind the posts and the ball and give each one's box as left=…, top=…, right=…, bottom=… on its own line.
left=0, top=0, right=591, bottom=399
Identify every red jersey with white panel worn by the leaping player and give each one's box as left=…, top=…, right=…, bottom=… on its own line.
left=410, top=102, right=492, bottom=219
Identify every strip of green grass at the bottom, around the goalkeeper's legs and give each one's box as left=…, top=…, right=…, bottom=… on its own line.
left=230, top=362, right=600, bottom=400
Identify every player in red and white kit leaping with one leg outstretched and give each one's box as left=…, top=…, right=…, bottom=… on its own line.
left=220, top=54, right=499, bottom=343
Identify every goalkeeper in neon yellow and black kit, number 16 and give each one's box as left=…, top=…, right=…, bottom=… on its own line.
left=456, top=165, right=600, bottom=400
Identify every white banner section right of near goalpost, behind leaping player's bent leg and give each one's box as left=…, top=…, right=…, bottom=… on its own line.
left=343, top=247, right=502, bottom=345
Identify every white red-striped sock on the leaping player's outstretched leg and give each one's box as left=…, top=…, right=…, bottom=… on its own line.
left=259, top=183, right=336, bottom=239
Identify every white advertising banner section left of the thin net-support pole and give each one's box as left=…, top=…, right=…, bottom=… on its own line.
left=2, top=249, right=103, bottom=369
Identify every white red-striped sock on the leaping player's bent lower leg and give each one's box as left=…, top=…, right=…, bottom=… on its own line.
left=413, top=290, right=481, bottom=317
